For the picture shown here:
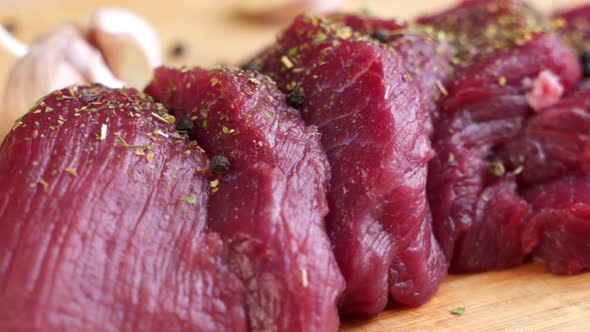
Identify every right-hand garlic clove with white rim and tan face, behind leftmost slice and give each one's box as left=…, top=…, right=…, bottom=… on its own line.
left=88, top=8, right=162, bottom=87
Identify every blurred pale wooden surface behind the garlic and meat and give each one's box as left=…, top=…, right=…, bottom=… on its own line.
left=0, top=0, right=590, bottom=96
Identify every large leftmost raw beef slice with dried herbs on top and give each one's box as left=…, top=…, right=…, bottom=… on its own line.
left=0, top=85, right=246, bottom=332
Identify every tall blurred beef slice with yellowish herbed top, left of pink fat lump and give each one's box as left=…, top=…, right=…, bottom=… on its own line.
left=419, top=0, right=580, bottom=272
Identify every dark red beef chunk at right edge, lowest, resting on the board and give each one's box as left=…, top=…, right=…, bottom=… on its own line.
left=524, top=176, right=590, bottom=274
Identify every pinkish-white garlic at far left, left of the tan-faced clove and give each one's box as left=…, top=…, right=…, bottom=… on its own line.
left=0, top=25, right=123, bottom=137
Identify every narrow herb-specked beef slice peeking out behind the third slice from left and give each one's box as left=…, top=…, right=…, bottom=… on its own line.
left=330, top=14, right=454, bottom=135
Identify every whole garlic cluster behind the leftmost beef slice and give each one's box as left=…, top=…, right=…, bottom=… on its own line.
left=0, top=9, right=161, bottom=140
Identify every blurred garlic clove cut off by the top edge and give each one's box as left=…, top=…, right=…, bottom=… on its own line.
left=235, top=0, right=343, bottom=23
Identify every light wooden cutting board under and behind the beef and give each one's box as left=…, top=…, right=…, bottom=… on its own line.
left=0, top=0, right=590, bottom=332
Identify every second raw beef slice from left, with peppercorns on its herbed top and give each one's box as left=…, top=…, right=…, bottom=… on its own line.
left=146, top=68, right=344, bottom=331
